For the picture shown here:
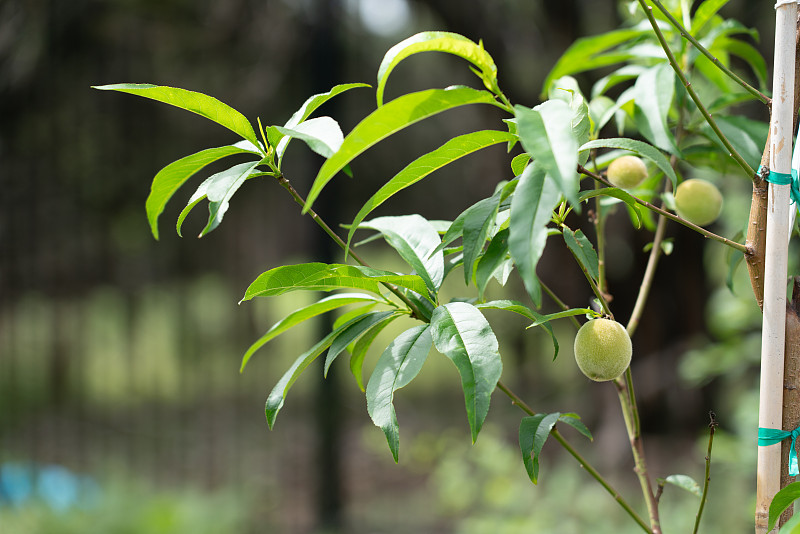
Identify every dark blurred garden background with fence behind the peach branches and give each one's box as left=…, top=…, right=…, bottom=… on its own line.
left=0, top=0, right=798, bottom=534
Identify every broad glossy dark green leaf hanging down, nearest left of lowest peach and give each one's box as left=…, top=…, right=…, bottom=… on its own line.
left=431, top=302, right=503, bottom=443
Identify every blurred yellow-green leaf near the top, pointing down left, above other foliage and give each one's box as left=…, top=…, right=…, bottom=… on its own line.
left=542, top=26, right=652, bottom=94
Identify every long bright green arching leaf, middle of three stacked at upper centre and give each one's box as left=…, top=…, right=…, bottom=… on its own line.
left=303, top=87, right=497, bottom=212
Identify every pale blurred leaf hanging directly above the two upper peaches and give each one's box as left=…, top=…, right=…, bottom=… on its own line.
left=634, top=63, right=680, bottom=156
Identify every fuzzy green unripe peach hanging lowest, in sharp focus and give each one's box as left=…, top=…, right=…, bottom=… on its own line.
left=575, top=319, right=633, bottom=382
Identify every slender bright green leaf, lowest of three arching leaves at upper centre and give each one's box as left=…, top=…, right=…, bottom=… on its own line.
left=347, top=130, right=516, bottom=253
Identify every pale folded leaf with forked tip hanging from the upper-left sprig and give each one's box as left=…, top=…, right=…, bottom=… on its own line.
left=177, top=161, right=261, bottom=237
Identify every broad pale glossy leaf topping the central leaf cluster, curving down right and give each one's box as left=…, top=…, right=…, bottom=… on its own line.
left=361, top=215, right=444, bottom=294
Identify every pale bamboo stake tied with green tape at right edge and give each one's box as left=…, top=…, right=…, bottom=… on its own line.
left=755, top=0, right=797, bottom=534
